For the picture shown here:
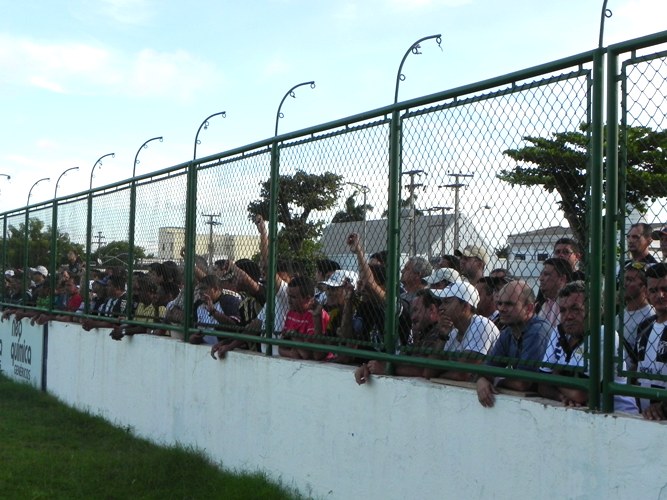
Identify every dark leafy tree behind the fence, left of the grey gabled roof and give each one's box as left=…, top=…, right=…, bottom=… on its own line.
left=248, top=170, right=343, bottom=261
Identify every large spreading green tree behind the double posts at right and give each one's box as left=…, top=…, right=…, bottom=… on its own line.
left=498, top=124, right=667, bottom=248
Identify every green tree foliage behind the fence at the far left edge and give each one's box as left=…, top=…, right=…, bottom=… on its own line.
left=0, top=219, right=84, bottom=268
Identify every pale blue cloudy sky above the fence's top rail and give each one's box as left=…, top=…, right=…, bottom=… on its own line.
left=0, top=0, right=667, bottom=212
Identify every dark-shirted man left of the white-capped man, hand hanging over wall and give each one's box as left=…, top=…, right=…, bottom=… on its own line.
left=354, top=289, right=443, bottom=384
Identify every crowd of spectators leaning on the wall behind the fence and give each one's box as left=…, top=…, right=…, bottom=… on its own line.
left=2, top=221, right=667, bottom=420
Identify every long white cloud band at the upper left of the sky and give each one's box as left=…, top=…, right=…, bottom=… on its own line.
left=0, top=35, right=222, bottom=100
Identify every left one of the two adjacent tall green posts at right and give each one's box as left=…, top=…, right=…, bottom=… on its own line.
left=588, top=49, right=604, bottom=410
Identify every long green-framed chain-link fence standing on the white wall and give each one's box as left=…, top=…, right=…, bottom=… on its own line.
left=2, top=33, right=667, bottom=410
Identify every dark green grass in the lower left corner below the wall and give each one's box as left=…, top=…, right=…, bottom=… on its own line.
left=0, top=376, right=300, bottom=499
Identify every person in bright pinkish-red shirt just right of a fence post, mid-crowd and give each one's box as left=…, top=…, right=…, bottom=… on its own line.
left=278, top=276, right=329, bottom=360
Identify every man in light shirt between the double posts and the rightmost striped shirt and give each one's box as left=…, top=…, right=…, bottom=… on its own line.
left=617, top=262, right=655, bottom=371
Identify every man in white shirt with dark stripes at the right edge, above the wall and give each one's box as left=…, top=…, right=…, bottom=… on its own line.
left=635, top=263, right=667, bottom=420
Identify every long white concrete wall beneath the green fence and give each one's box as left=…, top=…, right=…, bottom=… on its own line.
left=43, top=323, right=667, bottom=500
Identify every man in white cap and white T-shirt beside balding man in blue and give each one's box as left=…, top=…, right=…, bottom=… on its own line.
left=431, top=281, right=500, bottom=380
